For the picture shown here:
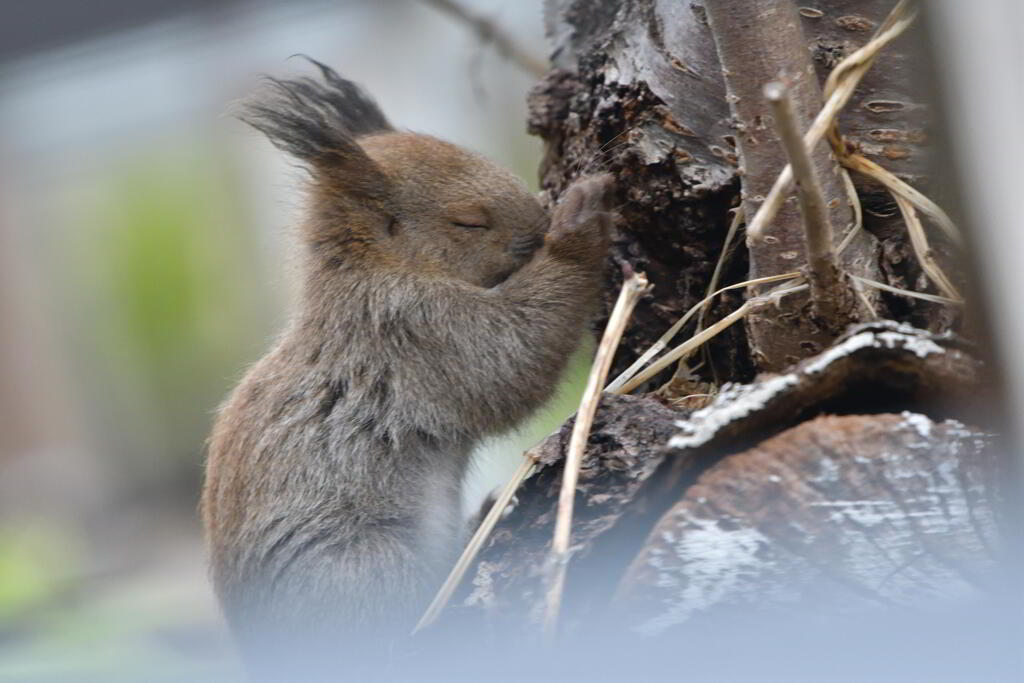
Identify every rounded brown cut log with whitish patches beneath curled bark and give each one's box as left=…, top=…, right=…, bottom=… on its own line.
left=618, top=413, right=1000, bottom=634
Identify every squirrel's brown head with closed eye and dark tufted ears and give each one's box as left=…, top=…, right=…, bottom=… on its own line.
left=240, top=60, right=548, bottom=287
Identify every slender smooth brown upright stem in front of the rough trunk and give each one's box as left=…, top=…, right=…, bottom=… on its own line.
left=706, top=0, right=878, bottom=371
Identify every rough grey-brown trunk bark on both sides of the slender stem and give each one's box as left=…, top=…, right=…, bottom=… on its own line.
left=529, top=0, right=956, bottom=386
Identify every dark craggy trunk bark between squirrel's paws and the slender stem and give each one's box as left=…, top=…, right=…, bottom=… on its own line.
left=529, top=0, right=753, bottom=389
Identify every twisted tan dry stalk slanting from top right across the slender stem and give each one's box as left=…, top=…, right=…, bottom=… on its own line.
left=746, top=0, right=915, bottom=241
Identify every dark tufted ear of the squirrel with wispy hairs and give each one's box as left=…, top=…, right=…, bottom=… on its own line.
left=236, top=57, right=393, bottom=198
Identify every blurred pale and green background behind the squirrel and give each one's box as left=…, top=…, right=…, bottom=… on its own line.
left=0, top=0, right=552, bottom=681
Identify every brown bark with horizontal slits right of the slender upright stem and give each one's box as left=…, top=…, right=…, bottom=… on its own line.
left=799, top=0, right=965, bottom=332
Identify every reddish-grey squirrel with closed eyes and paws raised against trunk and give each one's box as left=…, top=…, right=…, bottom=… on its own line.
left=201, top=59, right=611, bottom=671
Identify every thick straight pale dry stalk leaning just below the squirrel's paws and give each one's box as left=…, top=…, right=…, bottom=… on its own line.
left=544, top=273, right=647, bottom=637
